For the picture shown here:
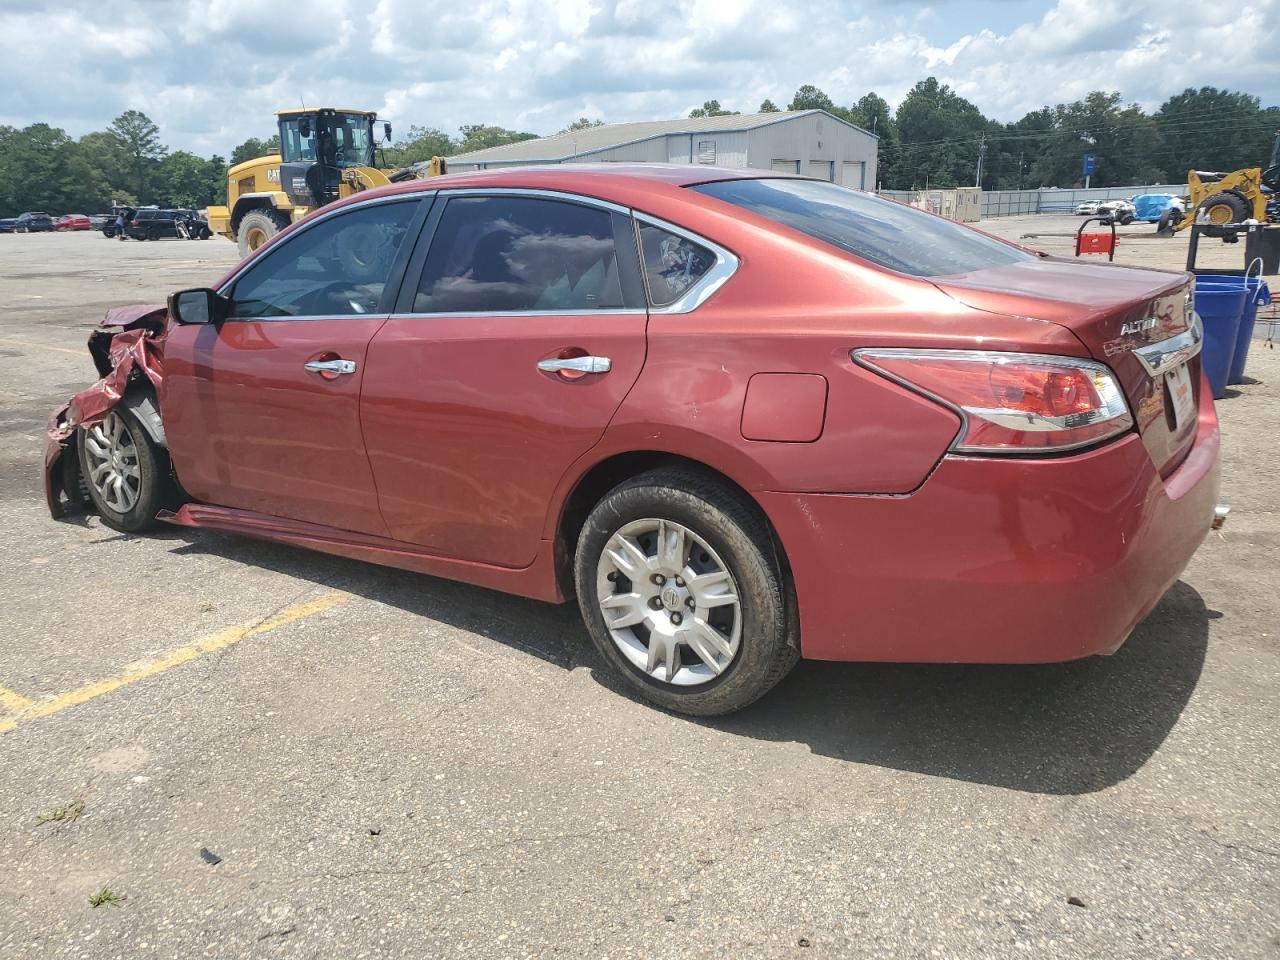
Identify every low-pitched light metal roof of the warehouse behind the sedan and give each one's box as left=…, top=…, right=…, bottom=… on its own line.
left=449, top=110, right=876, bottom=164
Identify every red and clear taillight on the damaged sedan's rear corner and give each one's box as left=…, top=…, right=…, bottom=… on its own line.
left=854, top=349, right=1133, bottom=453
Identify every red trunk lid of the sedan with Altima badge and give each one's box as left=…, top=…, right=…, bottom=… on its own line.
left=933, top=259, right=1201, bottom=474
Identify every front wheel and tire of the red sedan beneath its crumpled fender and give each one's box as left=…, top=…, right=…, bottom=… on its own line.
left=77, top=407, right=169, bottom=534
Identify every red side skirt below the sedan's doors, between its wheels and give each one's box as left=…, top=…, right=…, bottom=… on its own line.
left=157, top=503, right=564, bottom=603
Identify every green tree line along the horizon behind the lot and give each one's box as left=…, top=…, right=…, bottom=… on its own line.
left=0, top=77, right=1280, bottom=216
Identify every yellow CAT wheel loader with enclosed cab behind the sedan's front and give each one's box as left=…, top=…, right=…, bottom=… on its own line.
left=206, top=106, right=448, bottom=257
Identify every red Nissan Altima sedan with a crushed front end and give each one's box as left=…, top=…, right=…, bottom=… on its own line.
left=47, top=164, right=1220, bottom=714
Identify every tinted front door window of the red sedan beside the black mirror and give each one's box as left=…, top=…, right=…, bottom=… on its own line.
left=230, top=198, right=421, bottom=319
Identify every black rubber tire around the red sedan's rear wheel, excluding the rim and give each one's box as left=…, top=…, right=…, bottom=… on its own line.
left=573, top=468, right=799, bottom=717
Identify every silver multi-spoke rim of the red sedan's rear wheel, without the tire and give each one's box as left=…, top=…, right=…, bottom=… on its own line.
left=596, top=518, right=742, bottom=686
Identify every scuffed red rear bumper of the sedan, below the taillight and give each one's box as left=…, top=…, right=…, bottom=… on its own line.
left=758, top=390, right=1219, bottom=663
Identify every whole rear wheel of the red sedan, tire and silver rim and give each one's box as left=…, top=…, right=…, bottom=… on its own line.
left=575, top=470, right=799, bottom=717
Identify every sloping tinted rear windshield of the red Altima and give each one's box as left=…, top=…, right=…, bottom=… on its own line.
left=692, top=179, right=1034, bottom=276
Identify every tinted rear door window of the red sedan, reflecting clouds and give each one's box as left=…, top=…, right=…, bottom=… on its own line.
left=413, top=196, right=623, bottom=314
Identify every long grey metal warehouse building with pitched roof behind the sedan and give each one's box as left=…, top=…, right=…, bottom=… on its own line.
left=449, top=110, right=879, bottom=189
